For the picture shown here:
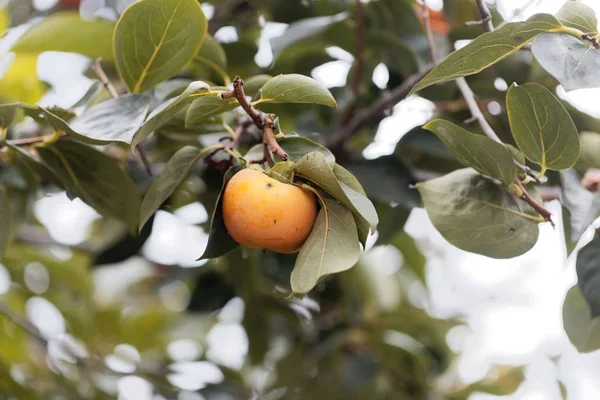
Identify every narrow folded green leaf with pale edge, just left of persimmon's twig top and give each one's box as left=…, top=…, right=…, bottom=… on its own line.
left=131, top=80, right=213, bottom=150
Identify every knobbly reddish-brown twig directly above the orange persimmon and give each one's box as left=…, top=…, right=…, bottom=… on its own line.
left=218, top=76, right=288, bottom=162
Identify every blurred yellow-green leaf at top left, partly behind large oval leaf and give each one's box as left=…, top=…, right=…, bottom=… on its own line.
left=11, top=11, right=114, bottom=61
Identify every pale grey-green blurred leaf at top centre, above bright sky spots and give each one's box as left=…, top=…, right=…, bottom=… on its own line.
left=271, top=12, right=350, bottom=58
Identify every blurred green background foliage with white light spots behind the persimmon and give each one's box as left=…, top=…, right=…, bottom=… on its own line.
left=0, top=0, right=572, bottom=400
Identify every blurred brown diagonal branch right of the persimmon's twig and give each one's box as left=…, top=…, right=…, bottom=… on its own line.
left=327, top=64, right=433, bottom=149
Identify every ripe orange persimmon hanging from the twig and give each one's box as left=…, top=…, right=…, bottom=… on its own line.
left=223, top=168, right=317, bottom=253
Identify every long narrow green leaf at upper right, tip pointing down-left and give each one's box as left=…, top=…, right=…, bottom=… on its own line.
left=409, top=14, right=562, bottom=95
